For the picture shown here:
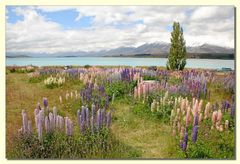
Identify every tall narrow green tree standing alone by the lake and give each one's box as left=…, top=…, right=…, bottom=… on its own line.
left=167, top=22, right=187, bottom=70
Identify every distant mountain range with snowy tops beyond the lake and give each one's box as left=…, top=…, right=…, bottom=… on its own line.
left=6, top=42, right=234, bottom=58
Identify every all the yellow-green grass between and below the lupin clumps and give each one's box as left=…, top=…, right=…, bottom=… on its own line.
left=6, top=70, right=234, bottom=159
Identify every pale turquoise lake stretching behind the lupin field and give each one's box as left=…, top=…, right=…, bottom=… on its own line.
left=6, top=57, right=234, bottom=69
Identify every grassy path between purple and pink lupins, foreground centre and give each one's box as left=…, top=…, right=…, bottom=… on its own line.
left=112, top=100, right=176, bottom=158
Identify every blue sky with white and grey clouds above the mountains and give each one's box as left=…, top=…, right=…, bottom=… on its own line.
left=6, top=6, right=234, bottom=54
